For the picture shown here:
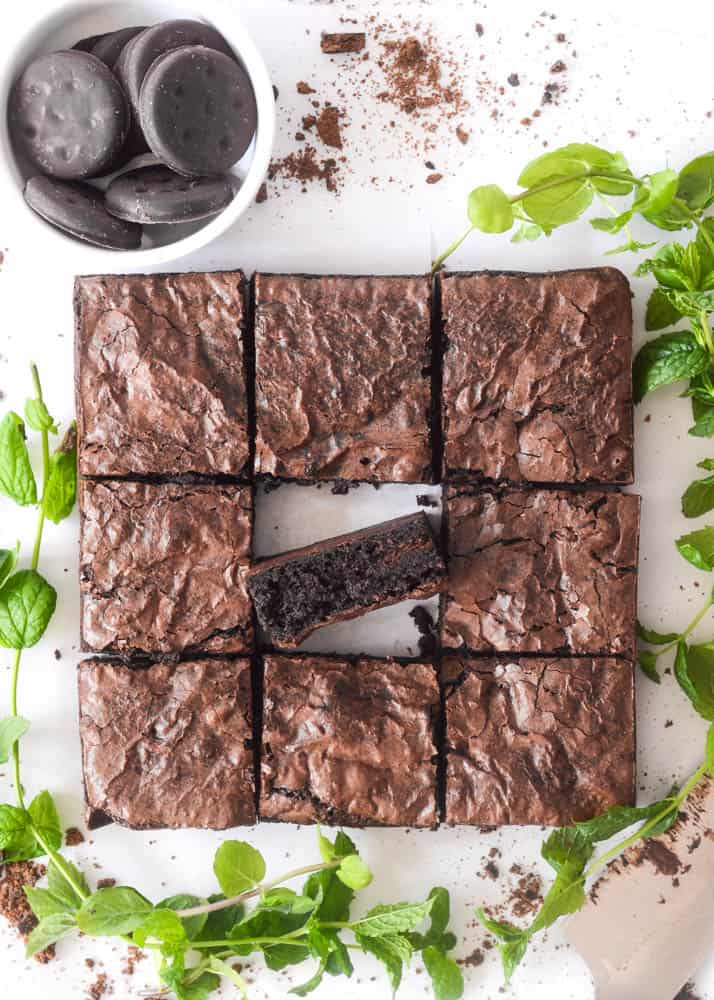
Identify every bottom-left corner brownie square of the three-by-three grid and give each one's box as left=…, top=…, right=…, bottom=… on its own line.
left=79, top=659, right=255, bottom=830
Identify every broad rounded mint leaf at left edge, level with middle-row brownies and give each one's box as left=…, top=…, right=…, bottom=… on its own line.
left=0, top=569, right=57, bottom=649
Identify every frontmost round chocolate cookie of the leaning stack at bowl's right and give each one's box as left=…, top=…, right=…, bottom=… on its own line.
left=140, top=45, right=258, bottom=177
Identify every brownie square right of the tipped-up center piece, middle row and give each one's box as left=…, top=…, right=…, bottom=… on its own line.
left=442, top=485, right=640, bottom=655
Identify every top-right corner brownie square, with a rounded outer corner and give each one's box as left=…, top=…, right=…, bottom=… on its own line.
left=439, top=267, right=633, bottom=483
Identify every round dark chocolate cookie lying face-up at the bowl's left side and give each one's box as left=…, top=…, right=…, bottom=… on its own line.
left=8, top=50, right=129, bottom=180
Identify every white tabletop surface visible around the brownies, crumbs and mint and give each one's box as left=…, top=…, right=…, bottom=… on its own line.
left=0, top=0, right=714, bottom=1000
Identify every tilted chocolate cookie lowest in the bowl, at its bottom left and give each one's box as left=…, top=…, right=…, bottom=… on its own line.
left=25, top=177, right=141, bottom=250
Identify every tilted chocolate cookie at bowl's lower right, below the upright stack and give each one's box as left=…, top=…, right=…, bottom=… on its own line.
left=104, top=166, right=233, bottom=225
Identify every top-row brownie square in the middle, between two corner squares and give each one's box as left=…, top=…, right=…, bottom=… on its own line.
left=254, top=274, right=432, bottom=483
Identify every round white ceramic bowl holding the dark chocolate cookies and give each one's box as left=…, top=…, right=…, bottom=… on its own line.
left=0, top=0, right=275, bottom=271
